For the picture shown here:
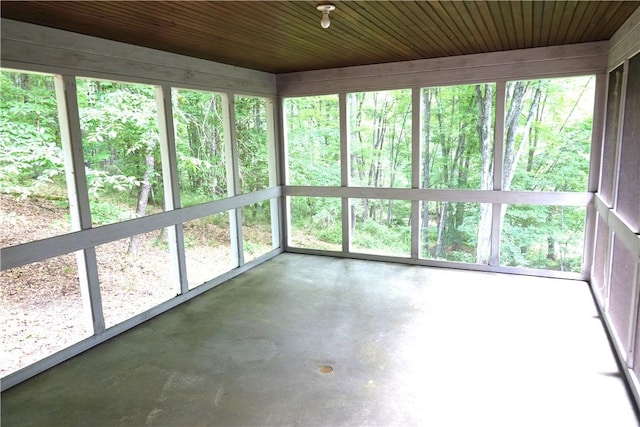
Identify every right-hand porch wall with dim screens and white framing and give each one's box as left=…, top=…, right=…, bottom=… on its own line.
left=591, top=8, right=640, bottom=403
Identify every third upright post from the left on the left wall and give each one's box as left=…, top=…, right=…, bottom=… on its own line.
left=222, top=92, right=244, bottom=267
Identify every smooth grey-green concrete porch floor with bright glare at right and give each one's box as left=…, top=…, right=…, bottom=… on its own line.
left=2, top=254, right=638, bottom=427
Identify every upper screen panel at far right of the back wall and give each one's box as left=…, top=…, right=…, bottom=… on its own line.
left=502, top=76, right=595, bottom=191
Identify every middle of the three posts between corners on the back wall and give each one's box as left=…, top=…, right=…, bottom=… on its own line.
left=411, top=87, right=422, bottom=259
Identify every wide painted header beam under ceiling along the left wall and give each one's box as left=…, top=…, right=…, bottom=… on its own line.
left=0, top=19, right=276, bottom=95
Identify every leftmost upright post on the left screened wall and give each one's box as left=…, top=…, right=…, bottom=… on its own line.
left=54, top=75, right=105, bottom=335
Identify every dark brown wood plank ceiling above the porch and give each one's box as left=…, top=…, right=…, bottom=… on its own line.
left=0, top=0, right=640, bottom=73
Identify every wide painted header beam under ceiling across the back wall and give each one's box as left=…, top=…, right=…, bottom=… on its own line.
left=277, top=42, right=609, bottom=96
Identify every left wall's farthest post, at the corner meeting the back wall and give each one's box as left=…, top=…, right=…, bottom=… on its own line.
left=266, top=98, right=282, bottom=249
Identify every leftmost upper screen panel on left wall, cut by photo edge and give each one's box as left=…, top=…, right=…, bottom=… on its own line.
left=0, top=70, right=72, bottom=247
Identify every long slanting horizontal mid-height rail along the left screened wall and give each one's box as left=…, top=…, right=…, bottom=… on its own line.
left=0, top=187, right=282, bottom=270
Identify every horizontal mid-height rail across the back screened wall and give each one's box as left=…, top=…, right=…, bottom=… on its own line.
left=282, top=186, right=593, bottom=207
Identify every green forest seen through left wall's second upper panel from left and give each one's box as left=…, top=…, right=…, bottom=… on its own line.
left=77, top=78, right=164, bottom=229
